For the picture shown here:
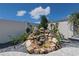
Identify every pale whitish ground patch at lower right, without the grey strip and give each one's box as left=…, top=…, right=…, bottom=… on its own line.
left=48, top=47, right=79, bottom=56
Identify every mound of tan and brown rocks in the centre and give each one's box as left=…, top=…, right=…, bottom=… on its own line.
left=25, top=28, right=60, bottom=54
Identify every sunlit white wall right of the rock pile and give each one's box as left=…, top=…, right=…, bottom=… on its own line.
left=58, top=21, right=73, bottom=39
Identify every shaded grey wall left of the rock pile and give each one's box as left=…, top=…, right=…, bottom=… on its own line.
left=0, top=20, right=25, bottom=43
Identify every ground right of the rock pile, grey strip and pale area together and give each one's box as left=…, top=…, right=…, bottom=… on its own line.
left=47, top=41, right=79, bottom=56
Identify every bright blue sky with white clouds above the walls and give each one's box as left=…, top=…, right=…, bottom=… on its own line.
left=0, top=3, right=79, bottom=22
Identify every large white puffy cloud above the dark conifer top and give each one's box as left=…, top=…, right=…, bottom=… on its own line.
left=30, top=6, right=50, bottom=19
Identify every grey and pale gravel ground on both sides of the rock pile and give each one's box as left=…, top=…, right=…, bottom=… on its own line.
left=0, top=41, right=79, bottom=56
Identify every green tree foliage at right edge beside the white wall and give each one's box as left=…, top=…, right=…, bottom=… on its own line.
left=68, top=13, right=79, bottom=35
